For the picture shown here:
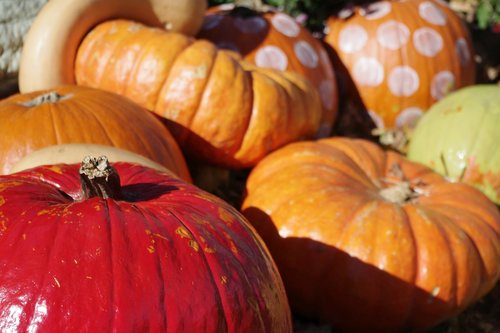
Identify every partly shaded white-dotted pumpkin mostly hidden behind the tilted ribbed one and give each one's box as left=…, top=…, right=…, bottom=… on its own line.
left=198, top=4, right=338, bottom=137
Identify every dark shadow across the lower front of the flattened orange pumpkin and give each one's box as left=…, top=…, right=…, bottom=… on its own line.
left=243, top=207, right=456, bottom=333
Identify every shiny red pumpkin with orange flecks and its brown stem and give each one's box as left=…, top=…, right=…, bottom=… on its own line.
left=0, top=157, right=292, bottom=332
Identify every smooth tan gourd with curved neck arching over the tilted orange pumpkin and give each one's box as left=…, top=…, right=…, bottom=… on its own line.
left=19, top=0, right=207, bottom=93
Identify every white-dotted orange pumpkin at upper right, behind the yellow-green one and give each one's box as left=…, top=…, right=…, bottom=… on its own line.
left=325, top=0, right=475, bottom=128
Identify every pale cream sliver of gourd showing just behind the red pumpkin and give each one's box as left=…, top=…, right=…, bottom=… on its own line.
left=10, top=143, right=175, bottom=176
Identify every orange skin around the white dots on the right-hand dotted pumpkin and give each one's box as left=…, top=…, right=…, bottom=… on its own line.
left=324, top=0, right=475, bottom=128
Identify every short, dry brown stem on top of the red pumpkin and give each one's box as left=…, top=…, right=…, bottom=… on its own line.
left=79, top=156, right=121, bottom=199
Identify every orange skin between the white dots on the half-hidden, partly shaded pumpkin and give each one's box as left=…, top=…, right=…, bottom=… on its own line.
left=197, top=6, right=338, bottom=136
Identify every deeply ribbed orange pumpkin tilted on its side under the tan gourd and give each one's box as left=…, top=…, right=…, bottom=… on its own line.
left=75, top=20, right=322, bottom=168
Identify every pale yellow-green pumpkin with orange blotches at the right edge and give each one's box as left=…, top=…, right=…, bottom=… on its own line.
left=408, top=84, right=500, bottom=204
